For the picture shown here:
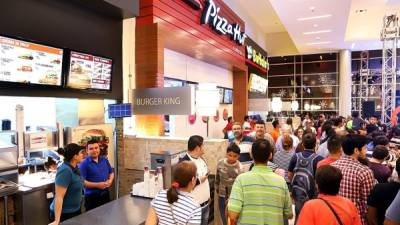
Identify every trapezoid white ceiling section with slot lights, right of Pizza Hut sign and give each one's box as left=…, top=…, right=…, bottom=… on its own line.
left=266, top=0, right=351, bottom=53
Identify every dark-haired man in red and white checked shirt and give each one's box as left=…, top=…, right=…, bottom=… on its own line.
left=331, top=134, right=376, bottom=225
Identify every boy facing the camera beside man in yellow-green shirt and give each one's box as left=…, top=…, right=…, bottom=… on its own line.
left=215, top=143, right=242, bottom=225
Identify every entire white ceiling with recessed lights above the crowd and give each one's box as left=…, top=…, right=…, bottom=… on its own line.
left=228, top=0, right=400, bottom=54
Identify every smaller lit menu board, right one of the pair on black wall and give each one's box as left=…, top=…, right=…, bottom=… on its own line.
left=67, top=51, right=112, bottom=90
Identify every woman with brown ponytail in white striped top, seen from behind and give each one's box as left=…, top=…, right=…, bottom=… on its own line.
left=146, top=161, right=201, bottom=225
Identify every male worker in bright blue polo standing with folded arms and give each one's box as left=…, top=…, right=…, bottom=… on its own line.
left=79, top=140, right=114, bottom=210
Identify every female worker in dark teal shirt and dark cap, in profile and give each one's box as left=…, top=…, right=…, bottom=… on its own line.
left=50, top=144, right=85, bottom=225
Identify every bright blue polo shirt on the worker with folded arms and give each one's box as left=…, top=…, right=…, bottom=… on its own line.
left=79, top=156, right=113, bottom=195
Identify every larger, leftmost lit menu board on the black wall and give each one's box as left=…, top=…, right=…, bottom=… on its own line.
left=0, top=36, right=63, bottom=86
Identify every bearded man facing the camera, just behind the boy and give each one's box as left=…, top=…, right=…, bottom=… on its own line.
left=230, top=122, right=254, bottom=162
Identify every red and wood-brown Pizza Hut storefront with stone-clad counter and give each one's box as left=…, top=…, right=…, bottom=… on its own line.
left=120, top=0, right=255, bottom=221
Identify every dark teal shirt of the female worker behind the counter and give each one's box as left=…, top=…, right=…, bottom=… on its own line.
left=50, top=162, right=83, bottom=213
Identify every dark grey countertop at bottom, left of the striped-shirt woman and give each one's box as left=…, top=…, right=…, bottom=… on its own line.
left=61, top=195, right=151, bottom=225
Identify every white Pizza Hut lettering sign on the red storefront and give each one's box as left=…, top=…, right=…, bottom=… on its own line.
left=200, top=0, right=247, bottom=45
